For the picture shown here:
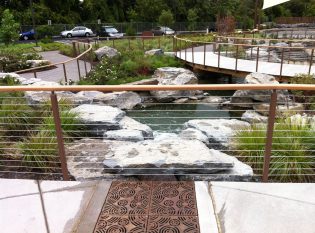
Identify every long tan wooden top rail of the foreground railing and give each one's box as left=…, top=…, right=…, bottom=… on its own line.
left=0, top=84, right=315, bottom=92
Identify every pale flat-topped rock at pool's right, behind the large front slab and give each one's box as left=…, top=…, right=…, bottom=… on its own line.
left=185, top=119, right=250, bottom=148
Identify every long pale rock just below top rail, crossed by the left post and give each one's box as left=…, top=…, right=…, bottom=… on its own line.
left=25, top=90, right=92, bottom=107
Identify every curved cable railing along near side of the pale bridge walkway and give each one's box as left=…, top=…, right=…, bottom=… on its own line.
left=174, top=36, right=315, bottom=81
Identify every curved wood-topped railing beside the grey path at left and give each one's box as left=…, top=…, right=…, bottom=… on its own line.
left=14, top=41, right=94, bottom=84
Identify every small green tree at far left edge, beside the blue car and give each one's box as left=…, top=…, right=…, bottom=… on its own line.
left=0, top=9, right=20, bottom=45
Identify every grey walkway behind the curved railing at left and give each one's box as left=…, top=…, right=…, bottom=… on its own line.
left=21, top=51, right=91, bottom=82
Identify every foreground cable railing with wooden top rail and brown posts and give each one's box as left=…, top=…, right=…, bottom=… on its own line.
left=0, top=84, right=315, bottom=182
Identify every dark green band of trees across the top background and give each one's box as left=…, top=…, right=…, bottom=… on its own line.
left=0, top=0, right=315, bottom=25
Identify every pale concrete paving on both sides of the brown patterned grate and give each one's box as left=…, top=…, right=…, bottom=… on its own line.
left=0, top=179, right=315, bottom=233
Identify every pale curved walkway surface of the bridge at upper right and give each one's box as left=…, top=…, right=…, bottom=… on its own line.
left=176, top=46, right=315, bottom=77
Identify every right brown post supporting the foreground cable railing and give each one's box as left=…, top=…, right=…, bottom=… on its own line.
left=262, top=90, right=277, bottom=182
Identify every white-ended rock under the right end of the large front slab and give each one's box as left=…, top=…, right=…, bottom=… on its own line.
left=179, top=157, right=254, bottom=182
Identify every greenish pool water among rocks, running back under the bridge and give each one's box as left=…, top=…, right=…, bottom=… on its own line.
left=127, top=73, right=246, bottom=133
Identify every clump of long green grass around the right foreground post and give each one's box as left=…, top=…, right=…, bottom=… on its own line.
left=233, top=120, right=315, bottom=182
